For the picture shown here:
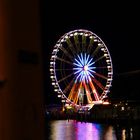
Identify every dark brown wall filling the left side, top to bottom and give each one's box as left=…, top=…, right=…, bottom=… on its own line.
left=0, top=0, right=44, bottom=140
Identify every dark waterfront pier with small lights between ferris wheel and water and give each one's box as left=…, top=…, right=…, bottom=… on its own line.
left=46, top=103, right=140, bottom=124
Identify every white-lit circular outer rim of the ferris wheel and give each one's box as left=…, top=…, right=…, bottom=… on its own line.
left=51, top=29, right=113, bottom=107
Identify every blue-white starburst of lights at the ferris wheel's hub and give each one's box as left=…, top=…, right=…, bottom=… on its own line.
left=73, top=53, right=96, bottom=82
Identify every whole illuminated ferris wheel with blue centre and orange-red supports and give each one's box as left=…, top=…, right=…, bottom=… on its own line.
left=50, top=29, right=113, bottom=109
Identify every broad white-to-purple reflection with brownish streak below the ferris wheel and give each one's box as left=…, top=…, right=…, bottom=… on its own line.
left=49, top=120, right=116, bottom=140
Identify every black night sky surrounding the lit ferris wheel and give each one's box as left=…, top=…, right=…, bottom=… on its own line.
left=41, top=0, right=140, bottom=104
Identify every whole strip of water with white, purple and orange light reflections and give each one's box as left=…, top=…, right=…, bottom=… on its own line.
left=47, top=120, right=139, bottom=140
